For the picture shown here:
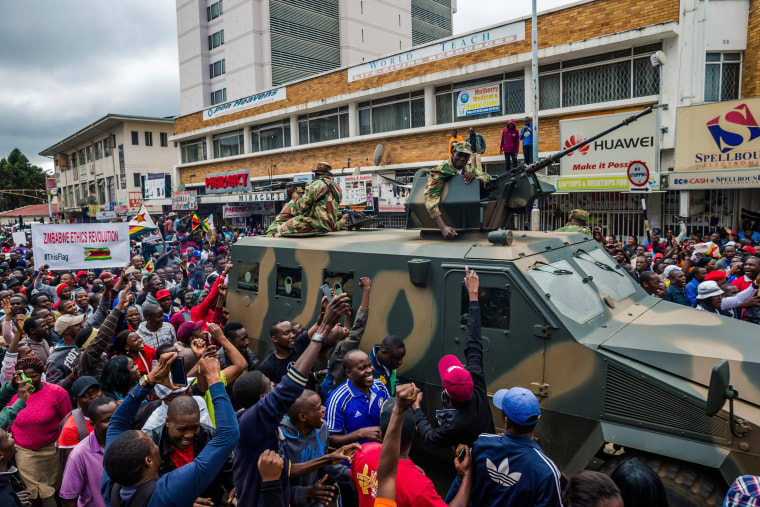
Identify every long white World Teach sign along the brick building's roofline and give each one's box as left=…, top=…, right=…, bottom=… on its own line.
left=348, top=21, right=525, bottom=82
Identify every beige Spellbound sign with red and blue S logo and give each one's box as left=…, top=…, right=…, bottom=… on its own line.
left=675, top=99, right=760, bottom=171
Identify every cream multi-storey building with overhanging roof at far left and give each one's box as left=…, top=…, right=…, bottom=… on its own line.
left=40, top=114, right=177, bottom=220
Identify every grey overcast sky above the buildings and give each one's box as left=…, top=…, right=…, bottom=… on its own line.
left=0, top=0, right=570, bottom=174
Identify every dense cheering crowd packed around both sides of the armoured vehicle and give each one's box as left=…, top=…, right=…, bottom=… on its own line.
left=0, top=204, right=760, bottom=507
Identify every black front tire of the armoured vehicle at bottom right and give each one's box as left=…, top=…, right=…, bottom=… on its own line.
left=599, top=453, right=728, bottom=507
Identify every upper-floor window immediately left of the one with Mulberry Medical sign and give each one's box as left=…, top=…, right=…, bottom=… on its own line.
left=359, top=90, right=425, bottom=135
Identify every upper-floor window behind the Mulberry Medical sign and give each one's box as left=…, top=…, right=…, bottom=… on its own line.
left=435, top=71, right=525, bottom=125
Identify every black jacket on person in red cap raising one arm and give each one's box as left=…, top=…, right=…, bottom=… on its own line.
left=414, top=301, right=496, bottom=447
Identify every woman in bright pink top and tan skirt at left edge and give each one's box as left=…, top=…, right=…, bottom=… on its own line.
left=9, top=356, right=71, bottom=505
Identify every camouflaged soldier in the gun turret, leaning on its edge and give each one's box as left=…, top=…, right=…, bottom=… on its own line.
left=425, top=143, right=491, bottom=239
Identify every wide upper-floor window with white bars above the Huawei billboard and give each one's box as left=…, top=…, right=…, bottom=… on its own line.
left=538, top=43, right=662, bottom=109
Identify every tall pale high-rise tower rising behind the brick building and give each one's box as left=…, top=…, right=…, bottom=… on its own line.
left=177, top=0, right=456, bottom=114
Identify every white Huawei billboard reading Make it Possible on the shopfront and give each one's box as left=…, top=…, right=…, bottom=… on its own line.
left=556, top=111, right=659, bottom=192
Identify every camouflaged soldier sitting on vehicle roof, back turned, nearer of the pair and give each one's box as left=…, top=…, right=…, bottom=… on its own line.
left=276, top=162, right=343, bottom=237
